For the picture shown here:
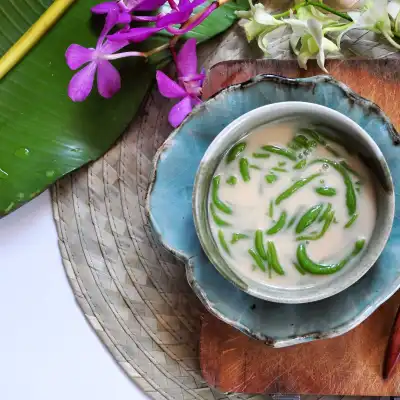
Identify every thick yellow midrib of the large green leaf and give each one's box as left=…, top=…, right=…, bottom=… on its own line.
left=0, top=0, right=75, bottom=79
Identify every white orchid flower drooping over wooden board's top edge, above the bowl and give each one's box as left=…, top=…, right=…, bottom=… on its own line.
left=285, top=14, right=339, bottom=73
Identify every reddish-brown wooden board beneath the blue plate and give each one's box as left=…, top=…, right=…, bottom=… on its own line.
left=200, top=60, right=400, bottom=396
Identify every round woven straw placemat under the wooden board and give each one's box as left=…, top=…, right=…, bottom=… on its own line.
left=52, top=16, right=398, bottom=400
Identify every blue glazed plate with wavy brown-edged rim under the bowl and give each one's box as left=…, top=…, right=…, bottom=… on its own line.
left=147, top=75, right=400, bottom=347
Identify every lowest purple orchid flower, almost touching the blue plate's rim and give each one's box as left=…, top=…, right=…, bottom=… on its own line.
left=156, top=39, right=205, bottom=128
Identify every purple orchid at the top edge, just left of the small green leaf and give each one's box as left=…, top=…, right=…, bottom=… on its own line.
left=108, top=0, right=212, bottom=42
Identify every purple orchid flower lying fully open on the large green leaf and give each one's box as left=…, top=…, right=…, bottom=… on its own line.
left=65, top=10, right=142, bottom=102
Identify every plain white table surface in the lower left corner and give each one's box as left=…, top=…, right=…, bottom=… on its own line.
left=0, top=192, right=147, bottom=400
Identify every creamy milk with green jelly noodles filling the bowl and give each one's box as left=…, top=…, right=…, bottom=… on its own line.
left=207, top=120, right=376, bottom=287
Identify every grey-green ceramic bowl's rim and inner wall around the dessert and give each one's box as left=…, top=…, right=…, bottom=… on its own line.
left=193, top=102, right=394, bottom=304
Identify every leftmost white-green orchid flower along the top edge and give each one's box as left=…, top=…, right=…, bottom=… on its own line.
left=236, top=1, right=284, bottom=42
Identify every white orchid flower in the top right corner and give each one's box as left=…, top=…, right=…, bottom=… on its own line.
left=337, top=0, right=400, bottom=49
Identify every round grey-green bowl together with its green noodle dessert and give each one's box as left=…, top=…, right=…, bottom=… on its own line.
left=193, top=102, right=394, bottom=303
